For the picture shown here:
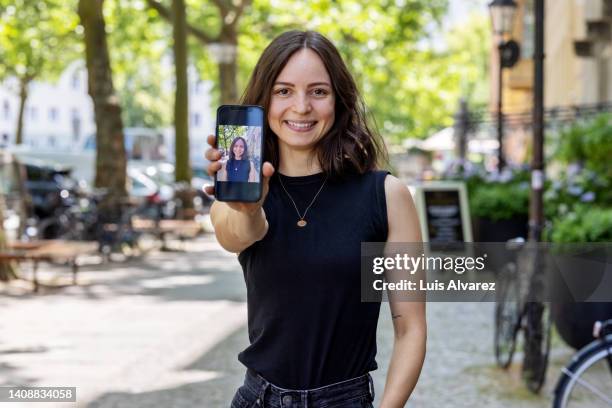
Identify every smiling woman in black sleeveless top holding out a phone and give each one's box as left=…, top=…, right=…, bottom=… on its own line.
left=206, top=31, right=426, bottom=408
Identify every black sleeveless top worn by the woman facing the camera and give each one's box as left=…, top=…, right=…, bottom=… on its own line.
left=238, top=171, right=388, bottom=389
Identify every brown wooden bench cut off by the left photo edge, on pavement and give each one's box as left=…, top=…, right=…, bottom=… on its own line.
left=0, top=240, right=98, bottom=292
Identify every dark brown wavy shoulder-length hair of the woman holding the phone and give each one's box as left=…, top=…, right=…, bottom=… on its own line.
left=241, top=30, right=388, bottom=178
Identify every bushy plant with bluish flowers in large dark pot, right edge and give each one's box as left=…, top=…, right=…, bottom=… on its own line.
left=544, top=114, right=612, bottom=349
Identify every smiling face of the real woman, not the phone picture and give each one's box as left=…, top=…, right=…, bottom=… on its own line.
left=268, top=48, right=335, bottom=155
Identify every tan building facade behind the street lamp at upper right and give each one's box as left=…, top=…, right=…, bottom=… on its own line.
left=489, top=0, right=612, bottom=163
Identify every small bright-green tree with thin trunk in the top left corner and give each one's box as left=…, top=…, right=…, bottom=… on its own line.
left=0, top=0, right=80, bottom=144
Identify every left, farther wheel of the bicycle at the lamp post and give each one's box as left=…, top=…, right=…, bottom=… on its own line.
left=494, top=264, right=521, bottom=369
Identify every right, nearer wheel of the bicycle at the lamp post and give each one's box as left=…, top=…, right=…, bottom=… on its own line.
left=522, top=302, right=552, bottom=393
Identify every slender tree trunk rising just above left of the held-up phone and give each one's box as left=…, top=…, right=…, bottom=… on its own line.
left=172, top=0, right=191, bottom=183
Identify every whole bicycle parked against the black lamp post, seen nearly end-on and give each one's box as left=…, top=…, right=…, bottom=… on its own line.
left=494, top=238, right=552, bottom=393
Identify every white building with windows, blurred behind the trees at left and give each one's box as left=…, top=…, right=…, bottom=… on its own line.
left=0, top=61, right=215, bottom=165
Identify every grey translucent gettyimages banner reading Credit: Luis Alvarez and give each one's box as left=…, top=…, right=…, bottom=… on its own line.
left=361, top=242, right=612, bottom=302
